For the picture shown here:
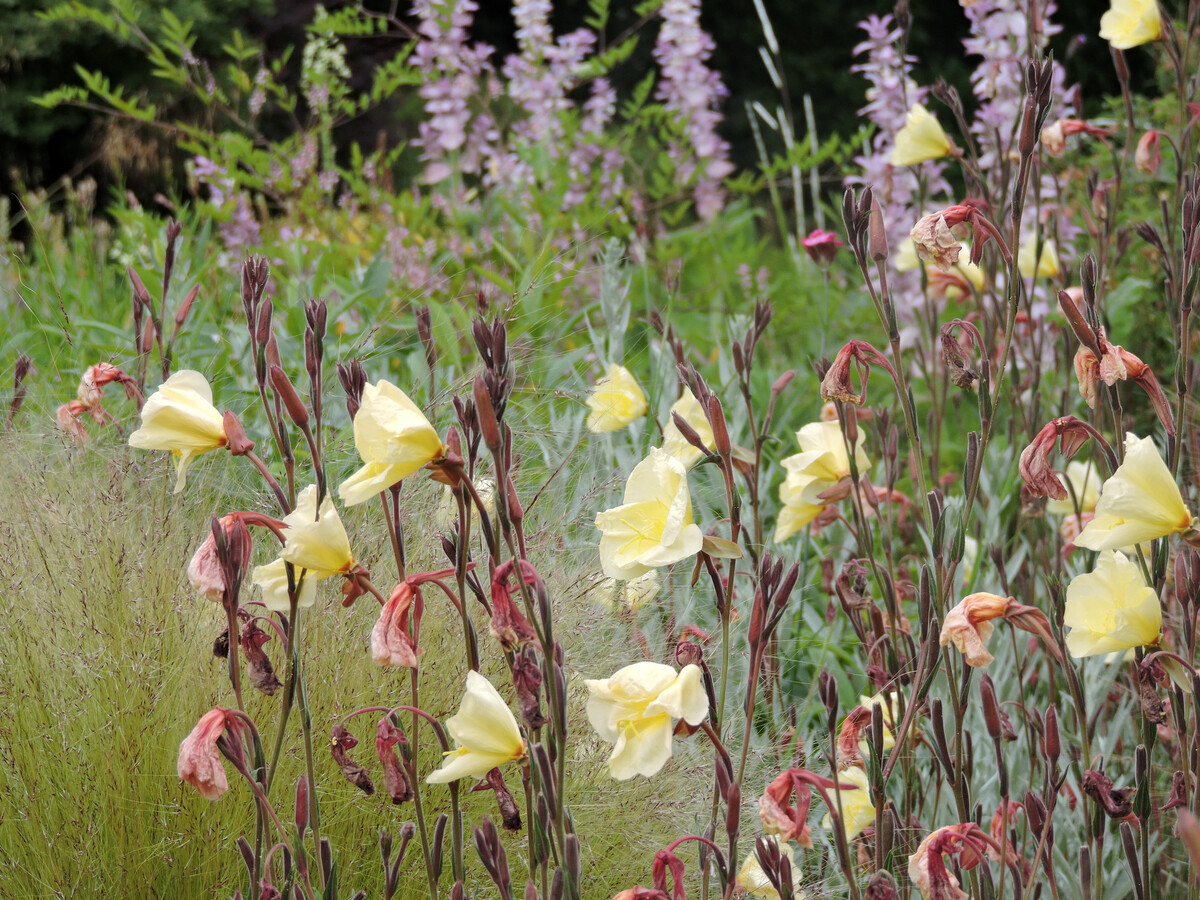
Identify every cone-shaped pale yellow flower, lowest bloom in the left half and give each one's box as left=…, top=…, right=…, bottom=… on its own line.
left=425, top=671, right=526, bottom=785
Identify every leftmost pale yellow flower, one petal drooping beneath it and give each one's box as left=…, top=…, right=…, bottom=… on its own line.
left=130, top=368, right=226, bottom=493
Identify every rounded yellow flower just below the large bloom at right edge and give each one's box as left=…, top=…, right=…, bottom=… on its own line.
left=1062, top=550, right=1163, bottom=659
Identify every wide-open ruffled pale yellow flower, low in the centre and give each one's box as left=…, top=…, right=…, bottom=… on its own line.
left=584, top=662, right=708, bottom=781
